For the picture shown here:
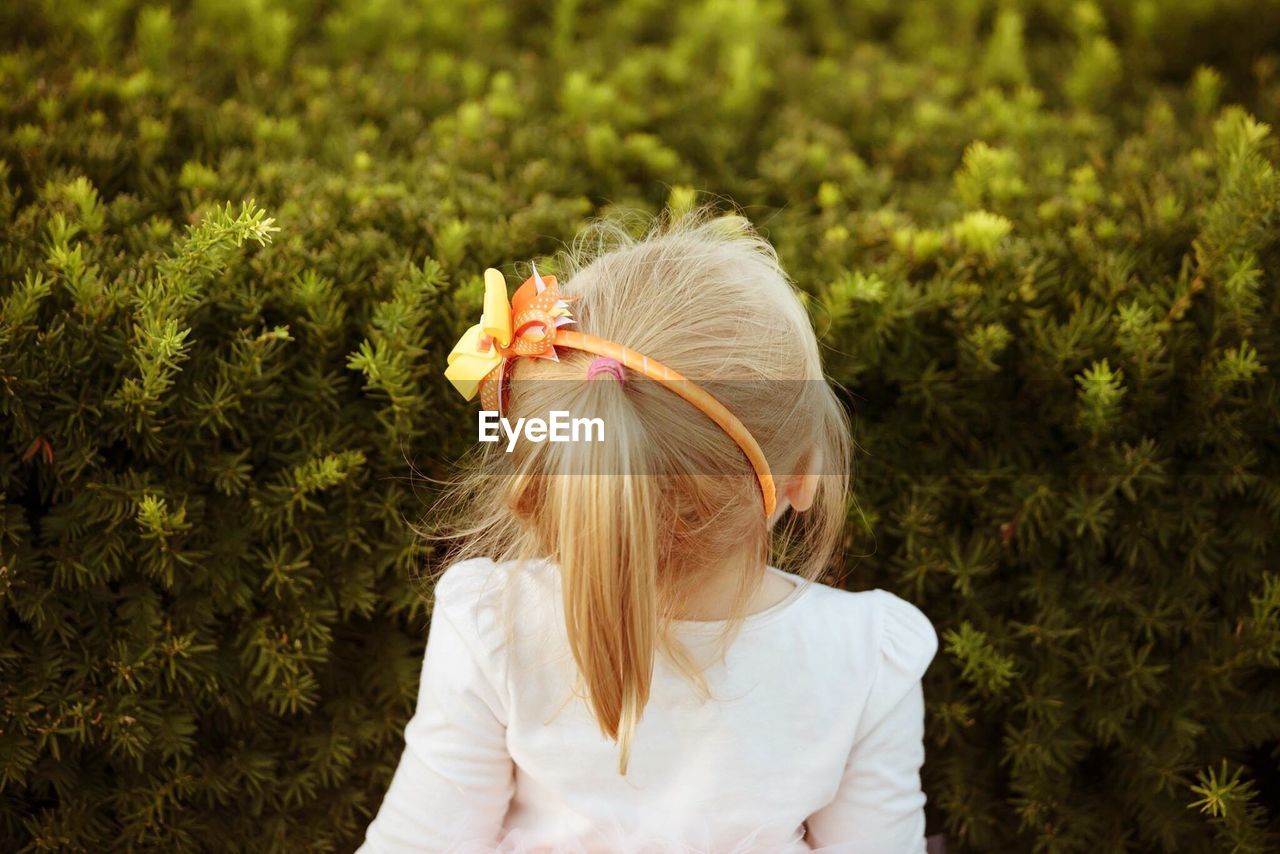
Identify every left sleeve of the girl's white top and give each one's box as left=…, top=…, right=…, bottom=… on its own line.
left=360, top=562, right=515, bottom=854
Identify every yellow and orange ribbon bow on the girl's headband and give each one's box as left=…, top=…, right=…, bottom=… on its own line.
left=444, top=266, right=573, bottom=411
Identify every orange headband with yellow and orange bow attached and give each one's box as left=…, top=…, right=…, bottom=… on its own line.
left=444, top=266, right=777, bottom=516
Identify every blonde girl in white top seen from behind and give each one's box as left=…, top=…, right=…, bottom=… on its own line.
left=361, top=211, right=937, bottom=854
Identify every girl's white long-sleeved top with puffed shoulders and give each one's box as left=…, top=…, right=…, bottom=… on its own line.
left=360, top=560, right=937, bottom=854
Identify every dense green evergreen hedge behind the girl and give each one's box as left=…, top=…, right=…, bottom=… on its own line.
left=0, top=0, right=1280, bottom=853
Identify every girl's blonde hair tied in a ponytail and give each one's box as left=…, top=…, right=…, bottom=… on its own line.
left=433, top=207, right=850, bottom=773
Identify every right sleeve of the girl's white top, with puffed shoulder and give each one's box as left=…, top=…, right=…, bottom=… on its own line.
left=806, top=590, right=938, bottom=854
